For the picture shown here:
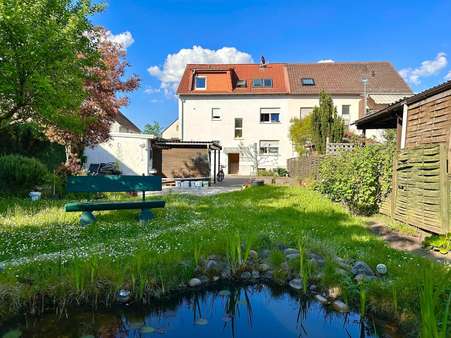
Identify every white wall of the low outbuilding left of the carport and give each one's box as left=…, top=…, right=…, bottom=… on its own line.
left=84, top=132, right=153, bottom=175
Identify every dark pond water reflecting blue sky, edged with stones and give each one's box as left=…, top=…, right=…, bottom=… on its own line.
left=0, top=285, right=399, bottom=338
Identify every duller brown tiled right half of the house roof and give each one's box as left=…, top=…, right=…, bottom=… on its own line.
left=287, top=62, right=412, bottom=94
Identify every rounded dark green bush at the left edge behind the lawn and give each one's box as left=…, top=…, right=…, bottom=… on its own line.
left=0, top=155, right=50, bottom=195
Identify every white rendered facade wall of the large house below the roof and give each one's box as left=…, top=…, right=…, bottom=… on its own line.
left=179, top=95, right=360, bottom=174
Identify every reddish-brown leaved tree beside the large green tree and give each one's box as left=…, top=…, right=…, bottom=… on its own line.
left=46, top=28, right=140, bottom=168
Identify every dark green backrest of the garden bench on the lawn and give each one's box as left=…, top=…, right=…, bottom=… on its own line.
left=67, top=175, right=161, bottom=192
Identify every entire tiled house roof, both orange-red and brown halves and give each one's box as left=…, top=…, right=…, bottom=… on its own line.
left=177, top=62, right=412, bottom=95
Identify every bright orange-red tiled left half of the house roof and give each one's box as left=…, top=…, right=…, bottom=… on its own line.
left=177, top=63, right=289, bottom=95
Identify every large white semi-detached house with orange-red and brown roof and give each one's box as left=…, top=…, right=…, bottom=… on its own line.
left=177, top=62, right=412, bottom=175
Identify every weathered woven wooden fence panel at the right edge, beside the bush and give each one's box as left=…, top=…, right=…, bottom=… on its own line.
left=380, top=144, right=451, bottom=234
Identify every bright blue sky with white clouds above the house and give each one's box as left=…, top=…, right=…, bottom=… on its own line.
left=93, top=0, right=451, bottom=127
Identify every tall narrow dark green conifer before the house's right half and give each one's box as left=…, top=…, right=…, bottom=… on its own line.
left=312, top=91, right=345, bottom=153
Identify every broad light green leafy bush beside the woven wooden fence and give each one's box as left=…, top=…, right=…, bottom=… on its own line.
left=316, top=145, right=393, bottom=215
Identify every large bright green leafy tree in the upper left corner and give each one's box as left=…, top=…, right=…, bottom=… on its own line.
left=0, top=0, right=102, bottom=132
